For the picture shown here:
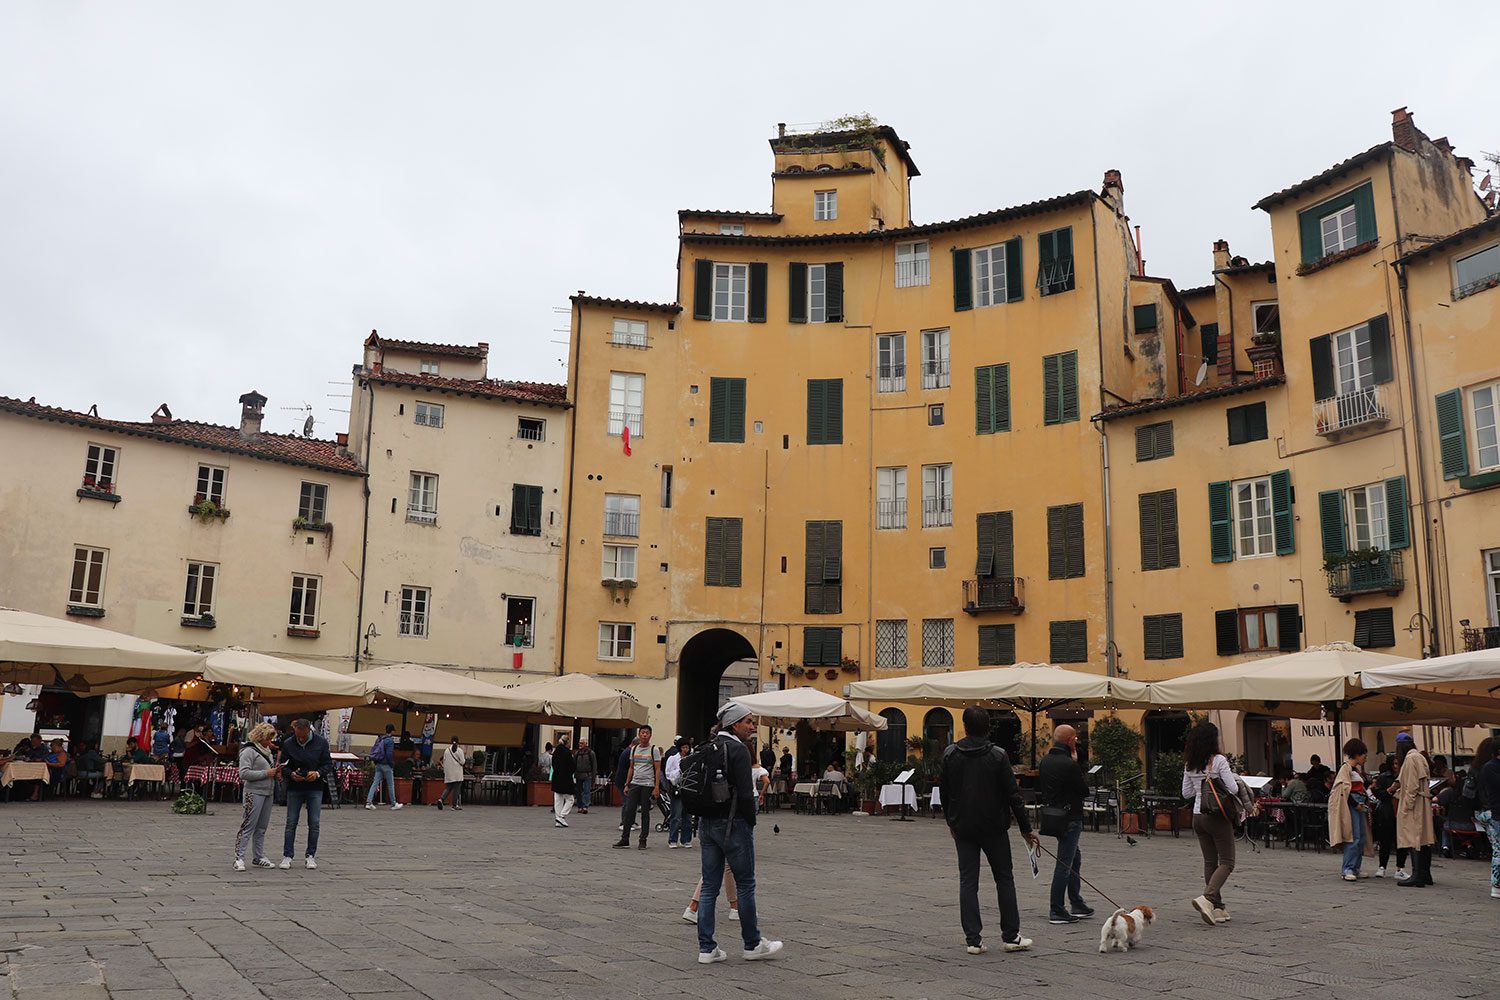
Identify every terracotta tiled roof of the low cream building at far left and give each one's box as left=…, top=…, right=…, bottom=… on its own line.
left=0, top=396, right=365, bottom=475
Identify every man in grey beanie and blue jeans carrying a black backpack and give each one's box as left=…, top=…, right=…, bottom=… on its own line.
left=698, top=702, right=782, bottom=966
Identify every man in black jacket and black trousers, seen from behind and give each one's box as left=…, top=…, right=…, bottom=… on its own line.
left=942, top=705, right=1041, bottom=955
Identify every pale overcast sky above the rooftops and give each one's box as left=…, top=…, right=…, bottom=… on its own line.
left=0, top=0, right=1500, bottom=436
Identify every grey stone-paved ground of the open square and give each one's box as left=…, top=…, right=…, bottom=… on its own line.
left=0, top=801, right=1500, bottom=1000
